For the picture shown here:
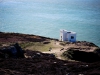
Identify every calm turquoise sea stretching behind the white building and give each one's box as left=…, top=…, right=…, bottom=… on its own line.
left=0, top=0, right=100, bottom=46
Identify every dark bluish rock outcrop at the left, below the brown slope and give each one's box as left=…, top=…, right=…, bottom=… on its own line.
left=0, top=43, right=25, bottom=58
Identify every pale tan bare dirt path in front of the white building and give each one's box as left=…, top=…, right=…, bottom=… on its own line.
left=43, top=41, right=95, bottom=59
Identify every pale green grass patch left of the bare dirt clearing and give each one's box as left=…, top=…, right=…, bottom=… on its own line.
left=20, top=42, right=53, bottom=52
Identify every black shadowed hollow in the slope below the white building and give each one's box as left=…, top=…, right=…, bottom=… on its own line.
left=63, top=49, right=100, bottom=62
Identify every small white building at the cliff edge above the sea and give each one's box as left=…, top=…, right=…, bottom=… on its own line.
left=60, top=30, right=76, bottom=42
